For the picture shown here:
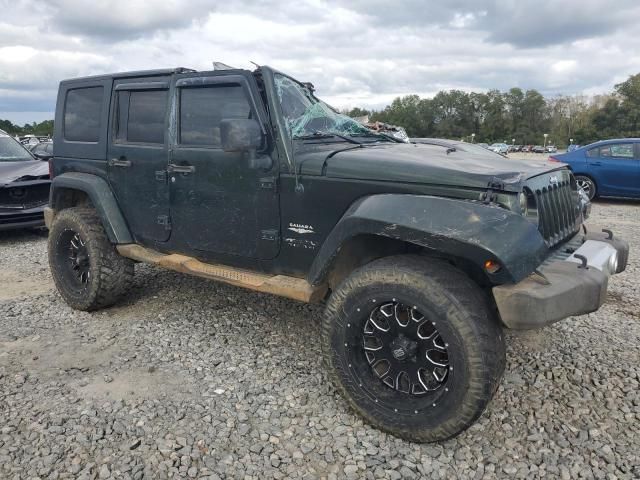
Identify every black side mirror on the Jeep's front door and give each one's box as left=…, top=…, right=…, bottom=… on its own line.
left=220, top=118, right=273, bottom=170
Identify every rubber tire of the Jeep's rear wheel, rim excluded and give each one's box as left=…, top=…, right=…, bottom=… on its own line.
left=48, top=207, right=134, bottom=311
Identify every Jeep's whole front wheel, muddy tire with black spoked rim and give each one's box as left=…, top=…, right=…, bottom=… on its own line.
left=322, top=255, right=505, bottom=442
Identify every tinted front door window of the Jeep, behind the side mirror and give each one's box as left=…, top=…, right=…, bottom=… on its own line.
left=180, top=85, right=251, bottom=147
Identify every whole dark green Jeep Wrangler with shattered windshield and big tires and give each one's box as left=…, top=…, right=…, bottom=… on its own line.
left=46, top=67, right=628, bottom=441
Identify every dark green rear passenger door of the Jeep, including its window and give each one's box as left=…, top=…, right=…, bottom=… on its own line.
left=107, top=77, right=171, bottom=244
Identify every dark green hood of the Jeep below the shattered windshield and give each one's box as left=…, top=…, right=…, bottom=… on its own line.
left=297, top=144, right=564, bottom=191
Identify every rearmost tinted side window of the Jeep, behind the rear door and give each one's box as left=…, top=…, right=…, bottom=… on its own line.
left=64, top=87, right=104, bottom=142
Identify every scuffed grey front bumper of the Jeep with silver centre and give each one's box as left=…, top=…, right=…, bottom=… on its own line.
left=493, top=229, right=629, bottom=330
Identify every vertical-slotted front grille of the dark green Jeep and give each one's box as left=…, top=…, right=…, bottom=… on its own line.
left=534, top=176, right=582, bottom=247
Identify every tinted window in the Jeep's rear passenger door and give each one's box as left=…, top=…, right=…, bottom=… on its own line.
left=126, top=90, right=168, bottom=143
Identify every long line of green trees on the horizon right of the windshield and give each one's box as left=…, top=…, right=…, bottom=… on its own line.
left=346, top=73, right=640, bottom=147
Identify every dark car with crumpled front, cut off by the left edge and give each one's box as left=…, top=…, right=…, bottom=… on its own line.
left=0, top=130, right=51, bottom=230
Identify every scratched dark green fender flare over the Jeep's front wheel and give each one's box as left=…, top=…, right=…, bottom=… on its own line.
left=308, top=194, right=547, bottom=286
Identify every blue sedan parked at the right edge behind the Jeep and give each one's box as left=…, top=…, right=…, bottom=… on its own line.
left=549, top=138, right=640, bottom=199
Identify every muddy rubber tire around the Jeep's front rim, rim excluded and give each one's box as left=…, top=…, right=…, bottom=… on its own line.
left=322, top=255, right=505, bottom=442
